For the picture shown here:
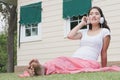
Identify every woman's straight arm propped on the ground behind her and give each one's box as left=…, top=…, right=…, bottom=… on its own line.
left=101, top=35, right=110, bottom=67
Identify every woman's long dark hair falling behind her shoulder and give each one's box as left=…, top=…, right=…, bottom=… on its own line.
left=88, top=6, right=110, bottom=30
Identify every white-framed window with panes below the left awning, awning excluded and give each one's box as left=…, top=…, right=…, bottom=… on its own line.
left=20, top=23, right=41, bottom=42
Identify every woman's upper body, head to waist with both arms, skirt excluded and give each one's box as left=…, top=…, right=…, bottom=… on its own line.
left=68, top=7, right=110, bottom=67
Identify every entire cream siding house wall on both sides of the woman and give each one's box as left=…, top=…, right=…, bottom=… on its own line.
left=17, top=0, right=120, bottom=66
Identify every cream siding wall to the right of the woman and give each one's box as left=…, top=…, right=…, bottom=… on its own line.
left=92, top=0, right=120, bottom=61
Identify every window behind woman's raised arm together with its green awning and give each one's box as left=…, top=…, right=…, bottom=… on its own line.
left=63, top=0, right=92, bottom=37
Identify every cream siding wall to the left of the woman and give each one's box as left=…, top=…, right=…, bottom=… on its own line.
left=17, top=0, right=79, bottom=66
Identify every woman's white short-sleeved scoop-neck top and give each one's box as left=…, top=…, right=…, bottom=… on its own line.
left=72, top=28, right=110, bottom=60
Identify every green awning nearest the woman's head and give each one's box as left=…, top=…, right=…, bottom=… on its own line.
left=63, top=0, right=91, bottom=18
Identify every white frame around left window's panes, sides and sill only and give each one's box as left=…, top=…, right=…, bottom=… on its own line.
left=20, top=23, right=42, bottom=42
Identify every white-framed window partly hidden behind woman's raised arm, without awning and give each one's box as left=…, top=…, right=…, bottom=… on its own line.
left=64, top=16, right=87, bottom=37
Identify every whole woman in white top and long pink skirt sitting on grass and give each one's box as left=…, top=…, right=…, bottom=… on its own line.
left=18, top=7, right=120, bottom=75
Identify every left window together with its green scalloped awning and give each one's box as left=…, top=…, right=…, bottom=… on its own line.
left=19, top=2, right=42, bottom=42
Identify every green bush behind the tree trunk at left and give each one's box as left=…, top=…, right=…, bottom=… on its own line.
left=0, top=34, right=17, bottom=72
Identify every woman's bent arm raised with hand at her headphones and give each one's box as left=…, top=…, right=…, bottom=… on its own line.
left=67, top=16, right=87, bottom=40
